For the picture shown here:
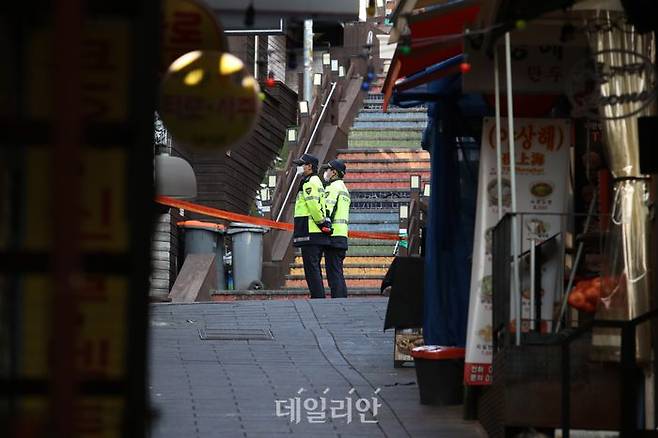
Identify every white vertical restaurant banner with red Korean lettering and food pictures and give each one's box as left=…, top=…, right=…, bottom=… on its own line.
left=464, top=118, right=572, bottom=385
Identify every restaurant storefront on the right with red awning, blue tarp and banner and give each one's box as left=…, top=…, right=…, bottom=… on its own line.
left=385, top=1, right=656, bottom=436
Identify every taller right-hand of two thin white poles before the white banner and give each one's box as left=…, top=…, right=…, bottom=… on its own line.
left=505, top=32, right=521, bottom=346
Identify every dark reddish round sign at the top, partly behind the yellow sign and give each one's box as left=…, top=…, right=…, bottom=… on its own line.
left=160, top=0, right=228, bottom=73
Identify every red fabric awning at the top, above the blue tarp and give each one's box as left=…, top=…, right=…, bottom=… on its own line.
left=384, top=0, right=480, bottom=111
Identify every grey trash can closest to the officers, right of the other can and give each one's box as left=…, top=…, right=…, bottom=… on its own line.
left=227, top=222, right=269, bottom=290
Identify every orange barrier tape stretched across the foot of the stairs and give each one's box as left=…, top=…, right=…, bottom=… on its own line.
left=155, top=196, right=400, bottom=240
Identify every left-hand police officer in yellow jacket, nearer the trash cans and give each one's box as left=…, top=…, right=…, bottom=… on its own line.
left=292, top=154, right=331, bottom=298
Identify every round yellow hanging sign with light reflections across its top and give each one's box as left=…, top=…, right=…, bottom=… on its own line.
left=160, top=50, right=261, bottom=151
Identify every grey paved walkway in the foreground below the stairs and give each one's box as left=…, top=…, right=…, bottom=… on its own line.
left=150, top=298, right=486, bottom=438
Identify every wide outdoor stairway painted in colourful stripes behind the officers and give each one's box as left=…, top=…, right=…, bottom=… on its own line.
left=284, top=89, right=430, bottom=295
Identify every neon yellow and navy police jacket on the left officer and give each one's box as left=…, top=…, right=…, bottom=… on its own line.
left=292, top=175, right=329, bottom=246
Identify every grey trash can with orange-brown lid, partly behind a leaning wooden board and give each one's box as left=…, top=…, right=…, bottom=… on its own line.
left=178, top=221, right=226, bottom=290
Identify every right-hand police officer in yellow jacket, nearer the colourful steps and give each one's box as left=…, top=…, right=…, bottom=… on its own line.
left=323, top=160, right=351, bottom=298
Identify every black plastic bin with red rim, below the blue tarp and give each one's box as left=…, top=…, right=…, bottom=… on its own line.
left=411, top=345, right=465, bottom=405
